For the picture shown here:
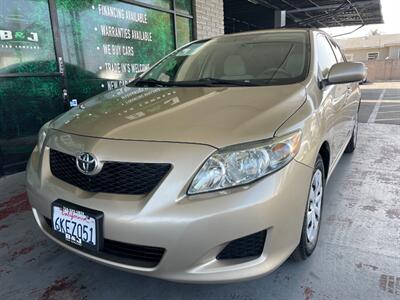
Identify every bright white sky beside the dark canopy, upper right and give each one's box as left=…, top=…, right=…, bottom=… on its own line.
left=321, top=0, right=400, bottom=38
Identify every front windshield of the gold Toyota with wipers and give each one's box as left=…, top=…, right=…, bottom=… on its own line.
left=131, top=32, right=309, bottom=86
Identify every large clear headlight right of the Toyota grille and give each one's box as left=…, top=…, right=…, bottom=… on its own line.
left=188, top=131, right=301, bottom=195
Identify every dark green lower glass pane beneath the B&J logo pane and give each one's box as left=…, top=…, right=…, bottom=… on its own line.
left=0, top=76, right=64, bottom=169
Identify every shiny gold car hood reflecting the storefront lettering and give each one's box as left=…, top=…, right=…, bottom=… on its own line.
left=51, top=84, right=306, bottom=148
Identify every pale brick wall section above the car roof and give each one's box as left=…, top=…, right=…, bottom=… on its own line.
left=195, top=0, right=224, bottom=39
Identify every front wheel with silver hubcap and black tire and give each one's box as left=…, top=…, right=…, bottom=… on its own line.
left=292, top=154, right=325, bottom=261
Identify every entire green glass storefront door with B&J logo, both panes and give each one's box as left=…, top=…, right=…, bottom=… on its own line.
left=0, top=0, right=64, bottom=174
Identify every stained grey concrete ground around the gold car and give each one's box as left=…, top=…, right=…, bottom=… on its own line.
left=0, top=84, right=400, bottom=300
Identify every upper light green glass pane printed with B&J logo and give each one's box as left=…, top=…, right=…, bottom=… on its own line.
left=0, top=0, right=57, bottom=74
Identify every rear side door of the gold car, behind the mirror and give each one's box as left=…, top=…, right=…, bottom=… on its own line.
left=330, top=40, right=361, bottom=142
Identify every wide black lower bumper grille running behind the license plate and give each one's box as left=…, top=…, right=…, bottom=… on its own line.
left=45, top=218, right=165, bottom=268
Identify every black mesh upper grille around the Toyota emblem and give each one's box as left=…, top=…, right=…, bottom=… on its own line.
left=50, top=149, right=171, bottom=195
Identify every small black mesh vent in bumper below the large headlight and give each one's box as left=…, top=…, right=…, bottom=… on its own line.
left=217, top=230, right=267, bottom=260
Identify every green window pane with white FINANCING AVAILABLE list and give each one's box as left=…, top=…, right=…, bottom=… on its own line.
left=57, top=0, right=175, bottom=102
